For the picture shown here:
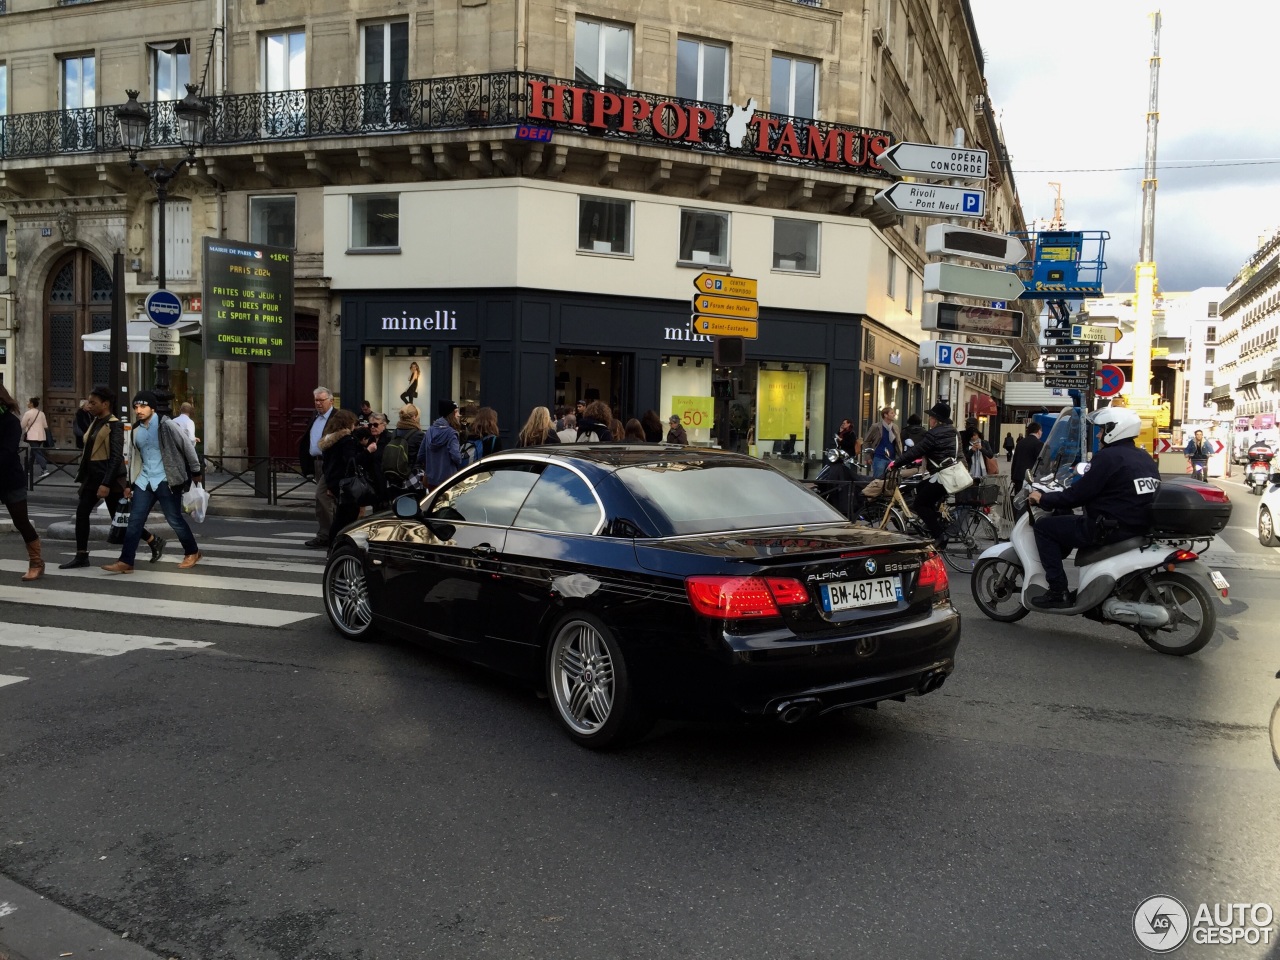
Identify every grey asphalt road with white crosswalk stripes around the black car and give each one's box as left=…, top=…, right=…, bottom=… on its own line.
left=0, top=506, right=1280, bottom=960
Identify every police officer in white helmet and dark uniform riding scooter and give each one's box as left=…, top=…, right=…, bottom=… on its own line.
left=1029, top=407, right=1160, bottom=611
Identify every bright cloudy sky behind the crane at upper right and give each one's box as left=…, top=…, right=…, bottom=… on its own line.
left=970, top=0, right=1280, bottom=293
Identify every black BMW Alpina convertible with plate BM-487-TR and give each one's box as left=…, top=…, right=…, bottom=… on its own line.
left=324, top=444, right=960, bottom=748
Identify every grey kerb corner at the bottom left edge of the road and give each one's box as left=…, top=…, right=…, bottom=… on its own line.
left=0, top=876, right=164, bottom=960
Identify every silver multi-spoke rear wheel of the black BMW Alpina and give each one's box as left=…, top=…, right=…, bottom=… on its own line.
left=547, top=613, right=648, bottom=750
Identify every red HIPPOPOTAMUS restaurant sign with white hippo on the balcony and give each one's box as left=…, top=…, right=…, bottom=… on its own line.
left=527, top=79, right=893, bottom=177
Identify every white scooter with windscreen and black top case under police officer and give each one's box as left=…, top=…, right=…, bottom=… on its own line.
left=970, top=408, right=1231, bottom=657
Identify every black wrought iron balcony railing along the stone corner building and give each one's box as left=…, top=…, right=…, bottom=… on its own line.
left=0, top=70, right=888, bottom=177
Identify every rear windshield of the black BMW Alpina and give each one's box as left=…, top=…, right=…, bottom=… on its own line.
left=616, top=462, right=845, bottom=535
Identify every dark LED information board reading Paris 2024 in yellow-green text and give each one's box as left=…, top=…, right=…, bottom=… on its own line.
left=204, top=237, right=293, bottom=364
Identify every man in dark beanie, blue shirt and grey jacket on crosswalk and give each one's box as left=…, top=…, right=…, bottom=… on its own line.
left=102, top=390, right=204, bottom=573
